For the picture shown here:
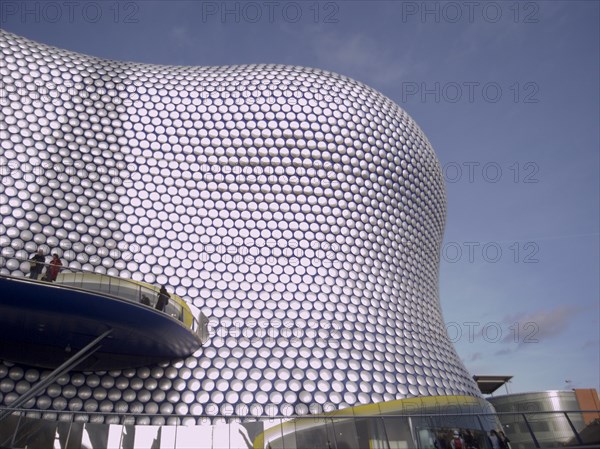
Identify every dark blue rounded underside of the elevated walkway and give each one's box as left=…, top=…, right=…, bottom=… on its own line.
left=0, top=277, right=200, bottom=371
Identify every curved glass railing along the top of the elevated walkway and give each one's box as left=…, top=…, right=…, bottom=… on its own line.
left=0, top=255, right=206, bottom=340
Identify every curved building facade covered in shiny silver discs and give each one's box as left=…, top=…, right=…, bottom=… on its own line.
left=0, top=32, right=479, bottom=424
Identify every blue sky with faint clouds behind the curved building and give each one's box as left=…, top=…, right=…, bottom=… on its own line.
left=0, top=0, right=600, bottom=393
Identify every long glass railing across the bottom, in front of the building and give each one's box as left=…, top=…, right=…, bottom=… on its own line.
left=0, top=407, right=600, bottom=449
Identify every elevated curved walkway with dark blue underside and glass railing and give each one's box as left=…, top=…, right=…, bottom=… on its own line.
left=0, top=264, right=208, bottom=371
